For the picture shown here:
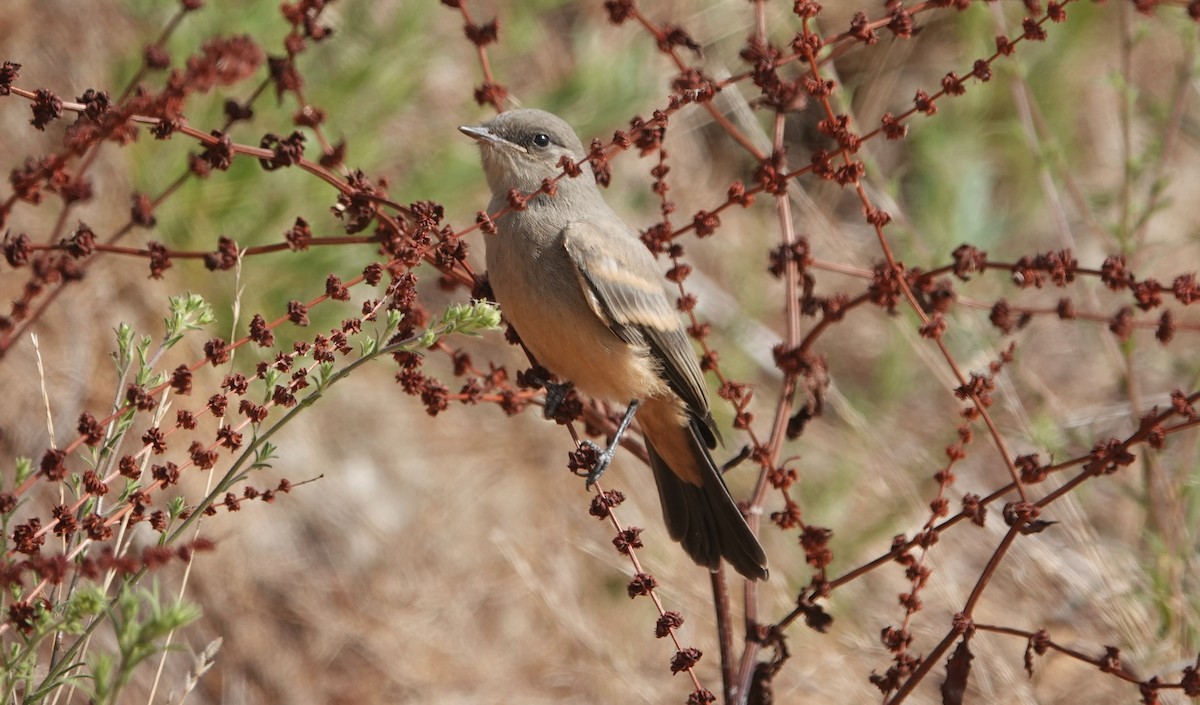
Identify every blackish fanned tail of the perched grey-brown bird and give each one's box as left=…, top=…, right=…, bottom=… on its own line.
left=646, top=417, right=767, bottom=580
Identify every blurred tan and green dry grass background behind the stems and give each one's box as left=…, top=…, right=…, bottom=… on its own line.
left=0, top=0, right=1200, bottom=704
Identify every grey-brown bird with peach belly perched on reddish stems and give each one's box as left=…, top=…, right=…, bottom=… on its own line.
left=458, top=109, right=768, bottom=580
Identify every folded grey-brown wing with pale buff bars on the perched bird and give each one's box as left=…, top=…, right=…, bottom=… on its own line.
left=563, top=221, right=715, bottom=446
